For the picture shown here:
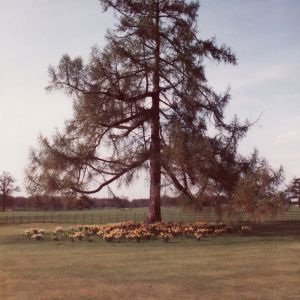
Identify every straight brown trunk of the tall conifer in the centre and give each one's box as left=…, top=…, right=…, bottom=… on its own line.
left=147, top=1, right=161, bottom=223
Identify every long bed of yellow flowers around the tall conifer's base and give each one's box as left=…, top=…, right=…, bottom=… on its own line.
left=24, top=222, right=251, bottom=243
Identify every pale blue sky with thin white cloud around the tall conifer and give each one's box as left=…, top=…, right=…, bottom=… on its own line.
left=0, top=0, right=300, bottom=198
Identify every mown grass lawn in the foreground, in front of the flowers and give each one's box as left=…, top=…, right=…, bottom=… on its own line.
left=0, top=224, right=300, bottom=300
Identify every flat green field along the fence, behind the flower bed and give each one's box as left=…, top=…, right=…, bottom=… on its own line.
left=0, top=207, right=300, bottom=225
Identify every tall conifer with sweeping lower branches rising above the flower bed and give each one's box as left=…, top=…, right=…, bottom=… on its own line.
left=27, top=0, right=248, bottom=222
